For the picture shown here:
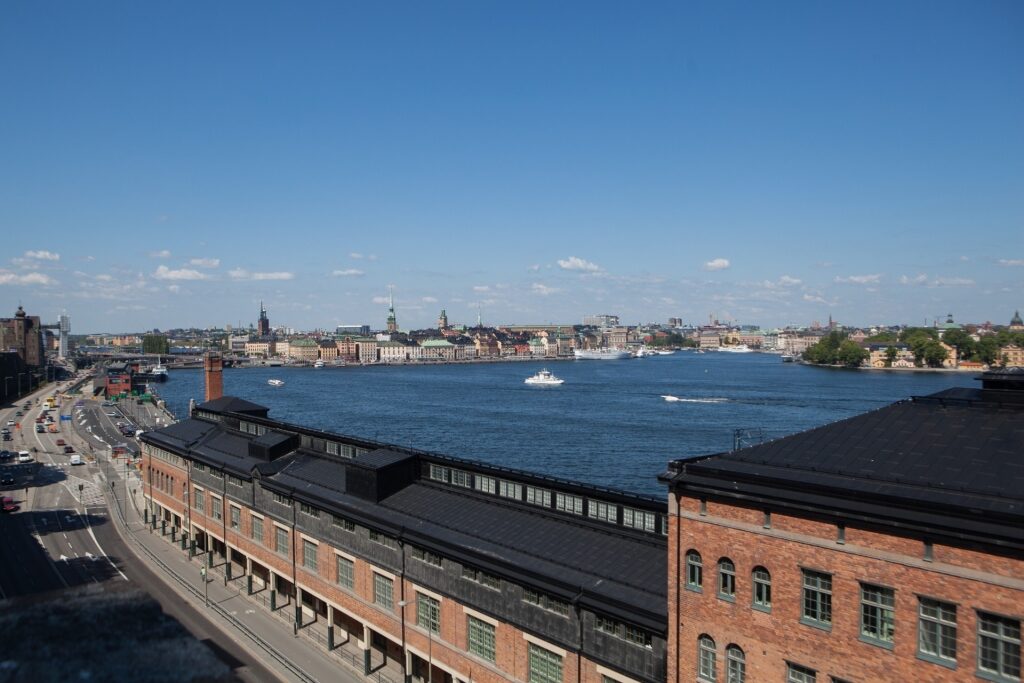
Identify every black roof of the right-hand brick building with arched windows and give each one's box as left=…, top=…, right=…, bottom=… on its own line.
left=662, top=382, right=1024, bottom=549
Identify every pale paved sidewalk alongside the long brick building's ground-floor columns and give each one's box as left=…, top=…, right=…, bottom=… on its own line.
left=100, top=458, right=402, bottom=683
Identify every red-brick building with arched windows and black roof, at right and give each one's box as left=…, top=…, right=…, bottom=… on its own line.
left=662, top=370, right=1024, bottom=683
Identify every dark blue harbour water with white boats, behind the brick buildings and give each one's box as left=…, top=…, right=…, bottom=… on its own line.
left=151, top=352, right=979, bottom=496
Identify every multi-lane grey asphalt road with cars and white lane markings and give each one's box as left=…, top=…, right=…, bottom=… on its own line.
left=0, top=378, right=279, bottom=681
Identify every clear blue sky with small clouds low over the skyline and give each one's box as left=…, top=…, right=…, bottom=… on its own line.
left=0, top=1, right=1024, bottom=332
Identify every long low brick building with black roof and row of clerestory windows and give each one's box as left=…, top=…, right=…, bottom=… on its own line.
left=141, top=396, right=667, bottom=683
